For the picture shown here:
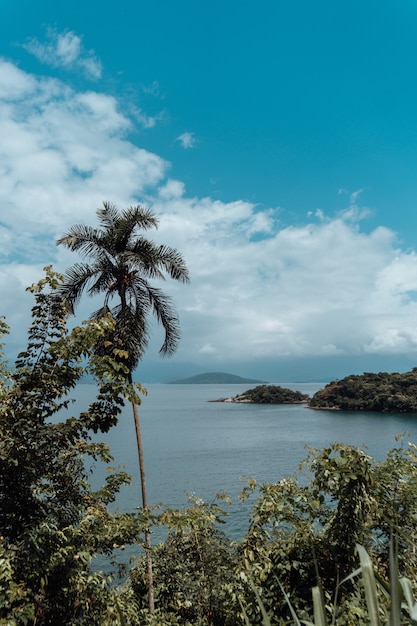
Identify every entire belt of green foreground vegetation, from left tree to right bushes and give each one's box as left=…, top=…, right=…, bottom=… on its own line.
left=4, top=268, right=417, bottom=626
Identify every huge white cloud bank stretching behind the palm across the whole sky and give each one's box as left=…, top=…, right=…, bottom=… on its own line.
left=0, top=57, right=417, bottom=368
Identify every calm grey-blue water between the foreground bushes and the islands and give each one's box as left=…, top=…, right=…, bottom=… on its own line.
left=70, top=383, right=417, bottom=538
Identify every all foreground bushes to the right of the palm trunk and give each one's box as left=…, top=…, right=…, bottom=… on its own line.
left=128, top=444, right=417, bottom=626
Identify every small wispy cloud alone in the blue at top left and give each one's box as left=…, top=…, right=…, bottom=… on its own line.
left=23, top=29, right=102, bottom=80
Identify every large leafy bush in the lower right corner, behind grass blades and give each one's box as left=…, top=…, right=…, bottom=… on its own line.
left=236, top=444, right=417, bottom=625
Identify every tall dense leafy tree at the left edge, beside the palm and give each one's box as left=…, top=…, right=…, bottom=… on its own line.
left=0, top=268, right=145, bottom=626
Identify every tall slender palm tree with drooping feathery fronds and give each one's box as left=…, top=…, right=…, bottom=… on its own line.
left=57, top=202, right=189, bottom=612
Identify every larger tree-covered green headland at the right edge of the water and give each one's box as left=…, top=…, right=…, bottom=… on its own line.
left=310, top=368, right=417, bottom=413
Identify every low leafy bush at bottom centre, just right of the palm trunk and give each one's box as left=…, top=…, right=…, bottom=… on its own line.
left=130, top=497, right=237, bottom=626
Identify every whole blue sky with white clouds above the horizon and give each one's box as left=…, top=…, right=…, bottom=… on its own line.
left=0, top=0, right=417, bottom=382
